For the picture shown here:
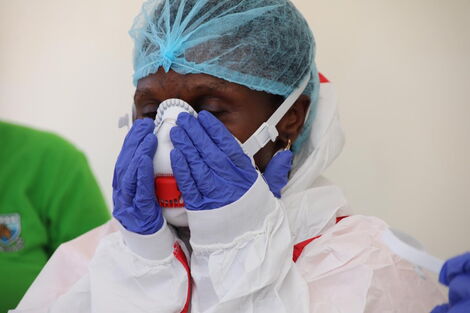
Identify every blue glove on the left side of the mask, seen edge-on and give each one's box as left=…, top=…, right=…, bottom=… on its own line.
left=113, top=118, right=163, bottom=235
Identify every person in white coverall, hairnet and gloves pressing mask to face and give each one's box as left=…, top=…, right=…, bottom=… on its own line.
left=13, top=0, right=470, bottom=313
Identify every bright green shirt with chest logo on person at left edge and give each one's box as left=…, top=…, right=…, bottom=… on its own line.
left=0, top=122, right=110, bottom=313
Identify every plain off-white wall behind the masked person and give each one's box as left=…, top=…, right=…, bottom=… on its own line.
left=0, top=0, right=470, bottom=258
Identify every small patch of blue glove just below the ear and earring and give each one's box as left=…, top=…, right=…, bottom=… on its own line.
left=263, top=150, right=293, bottom=198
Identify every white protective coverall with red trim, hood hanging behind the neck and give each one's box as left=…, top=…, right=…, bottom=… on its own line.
left=10, top=77, right=446, bottom=313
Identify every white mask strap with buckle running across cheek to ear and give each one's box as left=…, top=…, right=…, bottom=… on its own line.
left=242, top=74, right=310, bottom=157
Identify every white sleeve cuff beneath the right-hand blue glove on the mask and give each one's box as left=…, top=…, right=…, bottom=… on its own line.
left=187, top=173, right=278, bottom=245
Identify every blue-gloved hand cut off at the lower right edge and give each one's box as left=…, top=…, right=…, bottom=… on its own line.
left=431, top=252, right=470, bottom=313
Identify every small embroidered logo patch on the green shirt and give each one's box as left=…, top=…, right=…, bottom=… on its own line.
left=0, top=213, right=23, bottom=252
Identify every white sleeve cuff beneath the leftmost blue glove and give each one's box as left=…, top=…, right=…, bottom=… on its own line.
left=121, top=221, right=176, bottom=260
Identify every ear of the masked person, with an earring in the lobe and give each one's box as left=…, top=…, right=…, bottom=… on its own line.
left=277, top=95, right=310, bottom=145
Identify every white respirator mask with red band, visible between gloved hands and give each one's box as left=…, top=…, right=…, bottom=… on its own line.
left=153, top=99, right=197, bottom=227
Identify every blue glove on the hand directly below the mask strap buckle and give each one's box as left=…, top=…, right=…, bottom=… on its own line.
left=170, top=111, right=258, bottom=210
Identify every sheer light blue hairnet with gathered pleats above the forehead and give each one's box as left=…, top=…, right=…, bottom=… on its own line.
left=129, top=0, right=319, bottom=149
